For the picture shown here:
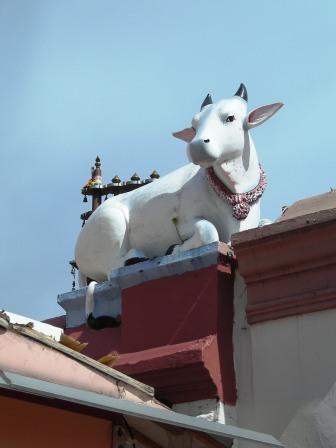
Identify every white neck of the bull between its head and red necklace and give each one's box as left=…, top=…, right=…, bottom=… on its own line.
left=213, top=134, right=260, bottom=193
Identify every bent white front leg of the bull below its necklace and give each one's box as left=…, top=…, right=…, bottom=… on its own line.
left=172, top=218, right=219, bottom=255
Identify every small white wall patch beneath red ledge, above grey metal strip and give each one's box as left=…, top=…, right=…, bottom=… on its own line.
left=172, top=398, right=236, bottom=425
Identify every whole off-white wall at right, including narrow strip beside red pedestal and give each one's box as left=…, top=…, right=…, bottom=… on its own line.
left=234, top=274, right=336, bottom=448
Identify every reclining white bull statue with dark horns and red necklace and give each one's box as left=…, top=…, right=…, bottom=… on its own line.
left=75, top=84, right=283, bottom=283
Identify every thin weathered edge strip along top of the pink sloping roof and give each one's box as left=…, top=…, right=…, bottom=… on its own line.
left=0, top=317, right=154, bottom=397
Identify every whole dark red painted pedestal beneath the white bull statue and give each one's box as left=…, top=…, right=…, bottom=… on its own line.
left=48, top=254, right=236, bottom=405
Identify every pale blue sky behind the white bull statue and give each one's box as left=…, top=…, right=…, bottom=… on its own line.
left=0, top=0, right=336, bottom=319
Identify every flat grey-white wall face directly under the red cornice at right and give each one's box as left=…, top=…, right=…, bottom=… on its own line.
left=251, top=310, right=336, bottom=436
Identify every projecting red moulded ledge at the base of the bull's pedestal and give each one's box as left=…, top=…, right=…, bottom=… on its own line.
left=113, top=335, right=220, bottom=403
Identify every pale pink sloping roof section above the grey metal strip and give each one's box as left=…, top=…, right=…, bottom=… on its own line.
left=0, top=313, right=155, bottom=400
